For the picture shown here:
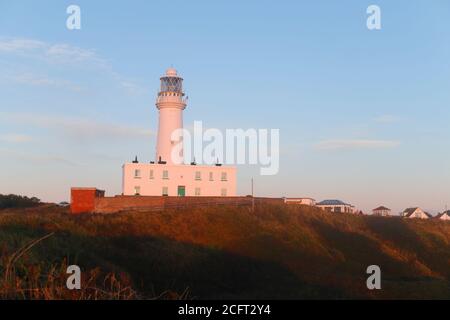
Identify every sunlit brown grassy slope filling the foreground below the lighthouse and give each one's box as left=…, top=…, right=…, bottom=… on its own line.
left=0, top=205, right=450, bottom=299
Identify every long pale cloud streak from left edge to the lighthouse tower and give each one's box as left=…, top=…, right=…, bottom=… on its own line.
left=0, top=113, right=153, bottom=141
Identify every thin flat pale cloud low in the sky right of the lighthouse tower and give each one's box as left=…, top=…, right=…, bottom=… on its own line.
left=314, top=139, right=400, bottom=151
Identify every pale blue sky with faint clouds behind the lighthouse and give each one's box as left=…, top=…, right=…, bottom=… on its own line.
left=0, top=0, right=450, bottom=212
